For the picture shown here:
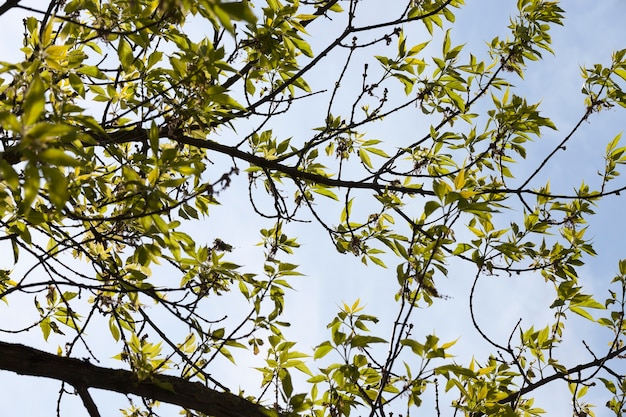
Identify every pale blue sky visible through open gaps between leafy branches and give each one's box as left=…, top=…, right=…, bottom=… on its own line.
left=0, top=0, right=626, bottom=417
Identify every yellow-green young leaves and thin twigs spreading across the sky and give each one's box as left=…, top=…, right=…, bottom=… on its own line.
left=0, top=0, right=626, bottom=417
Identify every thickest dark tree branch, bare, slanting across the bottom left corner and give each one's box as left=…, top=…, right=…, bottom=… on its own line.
left=0, top=342, right=274, bottom=417
